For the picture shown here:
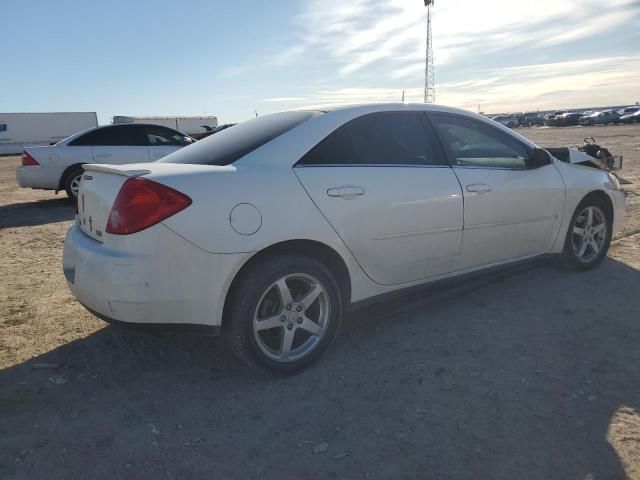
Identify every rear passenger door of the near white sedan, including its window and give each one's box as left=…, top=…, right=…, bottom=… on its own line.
left=294, top=111, right=463, bottom=285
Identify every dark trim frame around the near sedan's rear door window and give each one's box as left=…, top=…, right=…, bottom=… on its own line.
left=293, top=110, right=451, bottom=168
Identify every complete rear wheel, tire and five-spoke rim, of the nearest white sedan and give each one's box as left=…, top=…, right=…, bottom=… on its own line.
left=223, top=254, right=344, bottom=374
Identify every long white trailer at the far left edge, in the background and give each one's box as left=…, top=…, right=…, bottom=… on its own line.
left=0, top=112, right=98, bottom=154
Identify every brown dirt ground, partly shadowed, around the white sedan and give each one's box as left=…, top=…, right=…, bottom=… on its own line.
left=0, top=126, right=640, bottom=480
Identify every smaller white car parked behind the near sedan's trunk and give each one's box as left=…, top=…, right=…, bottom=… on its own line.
left=16, top=124, right=195, bottom=200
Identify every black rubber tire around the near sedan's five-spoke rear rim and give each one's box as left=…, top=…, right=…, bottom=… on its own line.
left=223, top=254, right=344, bottom=374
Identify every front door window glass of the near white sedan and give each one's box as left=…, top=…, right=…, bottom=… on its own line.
left=429, top=114, right=529, bottom=169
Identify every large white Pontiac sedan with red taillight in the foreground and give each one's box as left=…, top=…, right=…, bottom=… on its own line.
left=63, top=104, right=624, bottom=372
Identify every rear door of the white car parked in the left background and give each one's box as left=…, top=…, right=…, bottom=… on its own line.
left=93, top=125, right=149, bottom=164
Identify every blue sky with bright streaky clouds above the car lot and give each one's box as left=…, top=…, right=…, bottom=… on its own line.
left=0, top=0, right=640, bottom=124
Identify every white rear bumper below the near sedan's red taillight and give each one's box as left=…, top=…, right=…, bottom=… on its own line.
left=63, top=222, right=248, bottom=327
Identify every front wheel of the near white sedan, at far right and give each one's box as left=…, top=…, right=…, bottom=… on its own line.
left=562, top=199, right=612, bottom=271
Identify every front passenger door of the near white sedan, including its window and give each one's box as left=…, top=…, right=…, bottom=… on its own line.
left=429, top=113, right=565, bottom=270
